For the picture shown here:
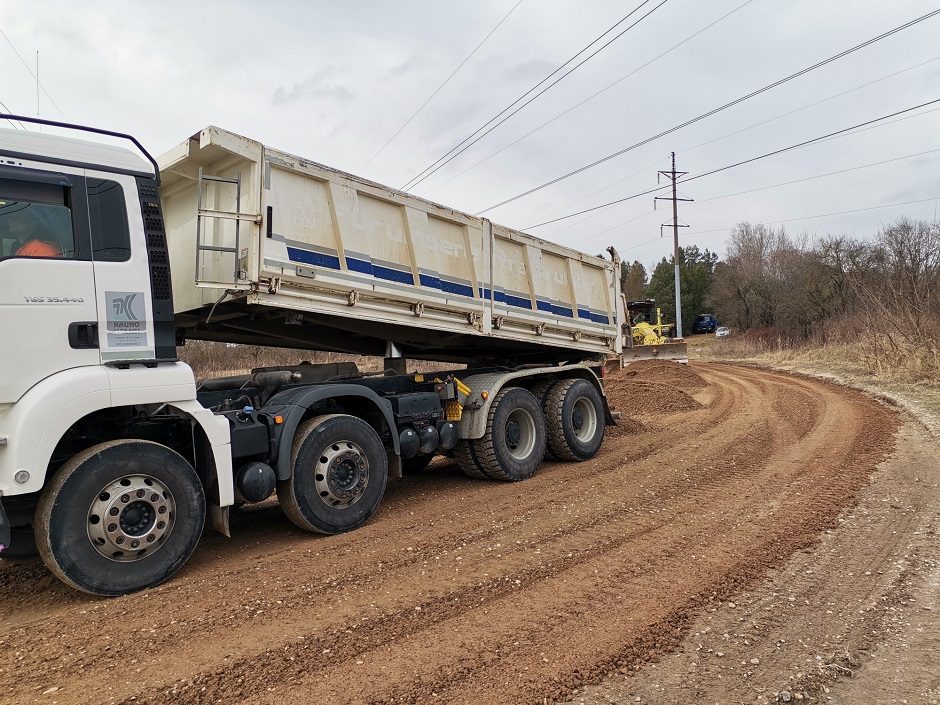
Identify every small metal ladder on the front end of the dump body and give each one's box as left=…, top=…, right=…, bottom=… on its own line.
left=195, top=167, right=259, bottom=289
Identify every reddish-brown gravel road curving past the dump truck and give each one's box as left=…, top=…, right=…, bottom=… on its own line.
left=0, top=365, right=936, bottom=704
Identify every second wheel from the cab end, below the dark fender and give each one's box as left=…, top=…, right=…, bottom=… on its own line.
left=277, top=414, right=388, bottom=534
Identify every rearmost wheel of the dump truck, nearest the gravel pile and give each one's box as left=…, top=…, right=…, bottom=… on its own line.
left=545, top=379, right=604, bottom=460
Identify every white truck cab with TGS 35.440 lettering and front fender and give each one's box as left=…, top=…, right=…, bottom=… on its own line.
left=0, top=124, right=232, bottom=584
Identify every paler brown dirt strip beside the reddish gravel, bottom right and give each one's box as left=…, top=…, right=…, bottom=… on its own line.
left=560, top=422, right=940, bottom=705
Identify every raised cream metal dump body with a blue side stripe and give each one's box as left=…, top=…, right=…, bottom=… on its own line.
left=158, top=127, right=624, bottom=362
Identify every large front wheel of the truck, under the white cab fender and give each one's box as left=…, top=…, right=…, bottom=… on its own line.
left=35, top=440, right=206, bottom=595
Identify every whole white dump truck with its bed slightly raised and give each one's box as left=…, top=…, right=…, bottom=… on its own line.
left=0, top=116, right=625, bottom=595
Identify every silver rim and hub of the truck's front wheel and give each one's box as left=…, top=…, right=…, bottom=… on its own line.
left=87, top=475, right=176, bottom=562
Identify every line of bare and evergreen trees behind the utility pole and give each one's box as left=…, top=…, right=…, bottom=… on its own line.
left=621, top=218, right=940, bottom=341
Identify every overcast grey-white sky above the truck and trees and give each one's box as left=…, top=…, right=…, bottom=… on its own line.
left=0, top=0, right=940, bottom=264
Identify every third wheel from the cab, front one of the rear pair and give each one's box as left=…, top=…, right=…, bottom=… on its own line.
left=469, top=387, right=545, bottom=482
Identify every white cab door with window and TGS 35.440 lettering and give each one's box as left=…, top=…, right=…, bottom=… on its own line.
left=0, top=161, right=100, bottom=404
